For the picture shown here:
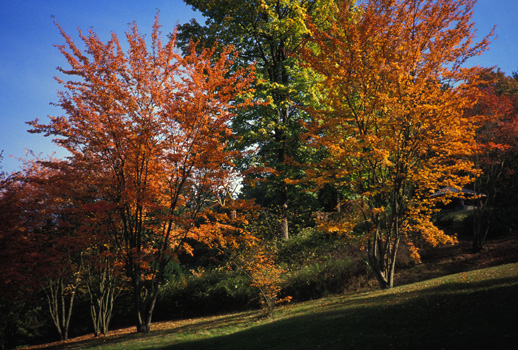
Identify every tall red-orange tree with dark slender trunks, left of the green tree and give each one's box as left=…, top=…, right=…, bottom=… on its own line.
left=30, top=16, right=254, bottom=332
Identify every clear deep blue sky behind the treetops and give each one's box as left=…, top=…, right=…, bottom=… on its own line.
left=0, top=0, right=518, bottom=172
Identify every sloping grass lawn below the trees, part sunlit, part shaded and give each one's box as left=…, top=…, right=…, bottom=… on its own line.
left=66, top=264, right=518, bottom=350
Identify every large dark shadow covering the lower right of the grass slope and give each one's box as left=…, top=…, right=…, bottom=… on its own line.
left=151, top=278, right=518, bottom=350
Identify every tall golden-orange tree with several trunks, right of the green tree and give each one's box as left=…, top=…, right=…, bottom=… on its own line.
left=302, top=0, right=494, bottom=288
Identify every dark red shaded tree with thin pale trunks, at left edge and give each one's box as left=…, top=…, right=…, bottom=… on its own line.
left=0, top=156, right=83, bottom=339
